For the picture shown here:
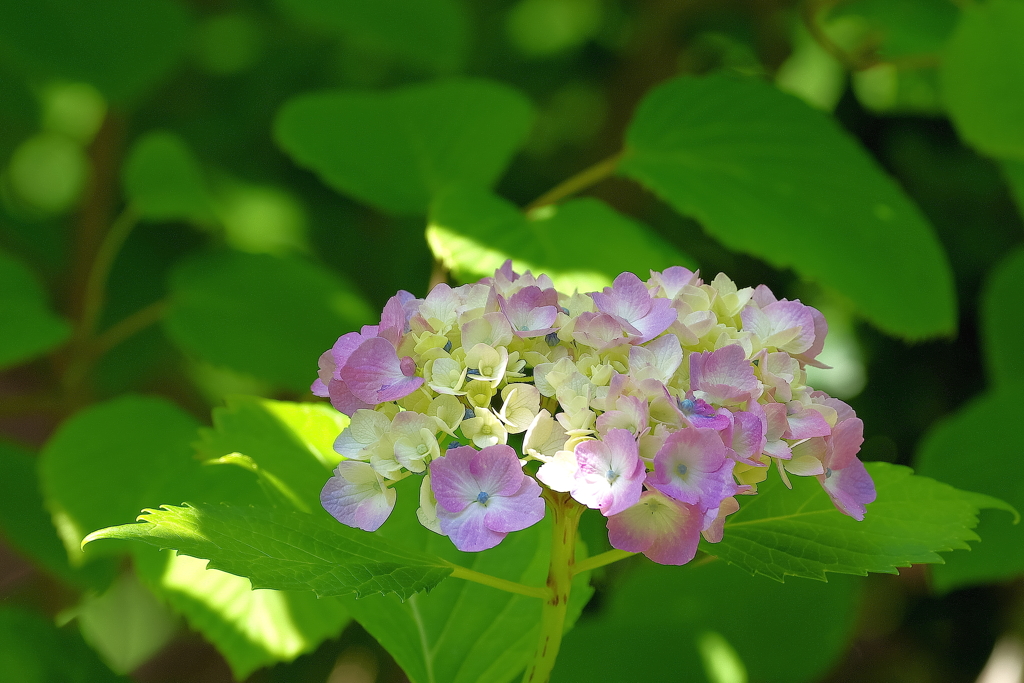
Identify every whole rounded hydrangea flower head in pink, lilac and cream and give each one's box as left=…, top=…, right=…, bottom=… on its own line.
left=312, top=262, right=874, bottom=564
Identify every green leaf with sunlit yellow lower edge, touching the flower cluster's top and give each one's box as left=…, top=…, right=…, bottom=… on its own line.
left=427, top=189, right=695, bottom=292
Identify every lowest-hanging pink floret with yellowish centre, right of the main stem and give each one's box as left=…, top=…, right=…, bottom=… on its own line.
left=608, top=490, right=703, bottom=564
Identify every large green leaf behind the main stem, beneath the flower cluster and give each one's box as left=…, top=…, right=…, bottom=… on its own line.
left=339, top=478, right=592, bottom=683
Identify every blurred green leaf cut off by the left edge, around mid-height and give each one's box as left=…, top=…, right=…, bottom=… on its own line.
left=0, top=252, right=71, bottom=368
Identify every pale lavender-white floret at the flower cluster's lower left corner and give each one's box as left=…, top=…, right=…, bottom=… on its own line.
left=321, top=461, right=395, bottom=531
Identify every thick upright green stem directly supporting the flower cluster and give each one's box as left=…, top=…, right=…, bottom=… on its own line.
left=522, top=490, right=584, bottom=683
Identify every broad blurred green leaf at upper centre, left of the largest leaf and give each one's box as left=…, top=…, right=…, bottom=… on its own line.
left=274, top=79, right=534, bottom=213
